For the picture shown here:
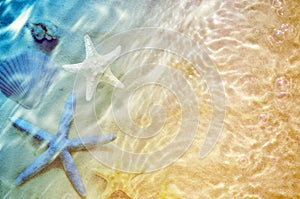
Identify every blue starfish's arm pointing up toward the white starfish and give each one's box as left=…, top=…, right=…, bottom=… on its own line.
left=57, top=92, right=75, bottom=138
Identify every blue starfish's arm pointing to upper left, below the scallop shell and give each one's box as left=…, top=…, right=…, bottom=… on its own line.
left=10, top=117, right=54, bottom=143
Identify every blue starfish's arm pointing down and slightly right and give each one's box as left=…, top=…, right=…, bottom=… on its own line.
left=60, top=149, right=86, bottom=196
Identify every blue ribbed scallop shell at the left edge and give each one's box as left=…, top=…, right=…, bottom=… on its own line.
left=0, top=50, right=59, bottom=109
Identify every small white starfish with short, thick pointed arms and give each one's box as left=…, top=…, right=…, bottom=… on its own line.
left=63, top=35, right=124, bottom=101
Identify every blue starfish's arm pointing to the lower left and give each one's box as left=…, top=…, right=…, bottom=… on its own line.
left=14, top=149, right=56, bottom=185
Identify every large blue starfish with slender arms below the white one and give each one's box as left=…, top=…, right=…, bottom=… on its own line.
left=10, top=93, right=116, bottom=196
